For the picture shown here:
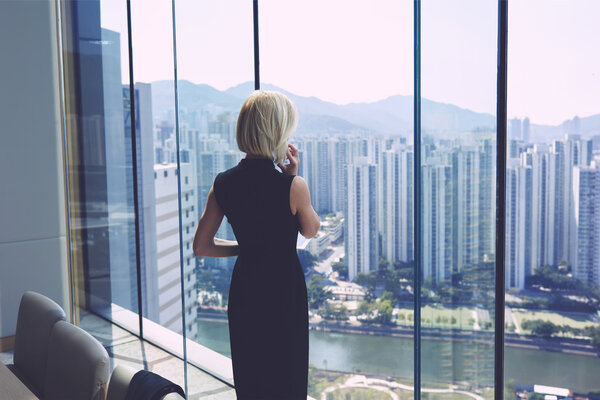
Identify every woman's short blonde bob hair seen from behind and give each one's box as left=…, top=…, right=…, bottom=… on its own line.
left=236, top=90, right=298, bottom=164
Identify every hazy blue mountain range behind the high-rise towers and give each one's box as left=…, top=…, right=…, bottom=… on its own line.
left=152, top=80, right=600, bottom=142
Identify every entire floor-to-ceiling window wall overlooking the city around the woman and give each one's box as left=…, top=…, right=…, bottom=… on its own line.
left=60, top=0, right=600, bottom=400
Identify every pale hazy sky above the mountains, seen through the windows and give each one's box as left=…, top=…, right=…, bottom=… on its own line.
left=101, top=0, right=600, bottom=124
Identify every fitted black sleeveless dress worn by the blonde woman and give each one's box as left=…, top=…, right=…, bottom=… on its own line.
left=213, top=158, right=308, bottom=400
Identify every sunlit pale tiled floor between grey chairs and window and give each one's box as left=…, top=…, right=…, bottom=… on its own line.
left=0, top=314, right=236, bottom=400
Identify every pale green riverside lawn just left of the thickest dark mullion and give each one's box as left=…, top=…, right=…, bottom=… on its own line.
left=396, top=304, right=473, bottom=329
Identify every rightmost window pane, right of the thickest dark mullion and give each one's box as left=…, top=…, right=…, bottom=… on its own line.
left=505, top=0, right=600, bottom=399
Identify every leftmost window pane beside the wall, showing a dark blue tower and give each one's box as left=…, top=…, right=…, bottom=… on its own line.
left=62, top=1, right=138, bottom=331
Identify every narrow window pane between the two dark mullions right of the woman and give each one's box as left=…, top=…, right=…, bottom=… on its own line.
left=417, top=1, right=497, bottom=398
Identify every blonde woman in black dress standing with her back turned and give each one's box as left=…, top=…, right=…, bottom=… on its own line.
left=194, top=91, right=320, bottom=400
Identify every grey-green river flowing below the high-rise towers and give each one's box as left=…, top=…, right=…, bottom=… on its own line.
left=198, top=319, right=600, bottom=393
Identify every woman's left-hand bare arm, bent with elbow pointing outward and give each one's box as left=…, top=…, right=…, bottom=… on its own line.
left=194, top=187, right=240, bottom=257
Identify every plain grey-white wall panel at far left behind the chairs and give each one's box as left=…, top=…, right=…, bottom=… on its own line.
left=0, top=0, right=69, bottom=338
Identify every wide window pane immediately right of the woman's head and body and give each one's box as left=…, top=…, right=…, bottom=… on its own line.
left=259, top=0, right=413, bottom=398
